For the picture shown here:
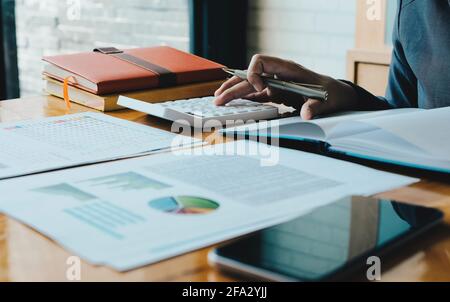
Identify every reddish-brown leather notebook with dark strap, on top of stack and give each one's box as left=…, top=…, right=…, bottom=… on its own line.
left=43, top=46, right=226, bottom=95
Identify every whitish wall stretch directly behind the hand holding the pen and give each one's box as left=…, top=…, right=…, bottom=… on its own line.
left=248, top=0, right=357, bottom=78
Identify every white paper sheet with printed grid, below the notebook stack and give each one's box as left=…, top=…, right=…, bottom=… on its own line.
left=0, top=113, right=201, bottom=179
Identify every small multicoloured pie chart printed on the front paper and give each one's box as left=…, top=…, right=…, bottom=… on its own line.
left=149, top=196, right=220, bottom=215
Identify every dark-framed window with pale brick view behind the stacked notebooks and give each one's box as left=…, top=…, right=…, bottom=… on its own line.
left=7, top=0, right=247, bottom=96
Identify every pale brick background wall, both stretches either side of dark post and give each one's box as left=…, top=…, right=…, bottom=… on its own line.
left=16, top=0, right=356, bottom=95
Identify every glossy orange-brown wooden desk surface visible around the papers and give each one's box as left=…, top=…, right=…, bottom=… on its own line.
left=0, top=96, right=450, bottom=281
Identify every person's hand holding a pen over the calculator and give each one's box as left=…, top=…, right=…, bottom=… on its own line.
left=215, top=55, right=357, bottom=120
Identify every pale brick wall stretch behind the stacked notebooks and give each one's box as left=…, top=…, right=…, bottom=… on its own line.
left=16, top=0, right=189, bottom=95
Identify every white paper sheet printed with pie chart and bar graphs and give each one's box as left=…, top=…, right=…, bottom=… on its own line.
left=0, top=141, right=417, bottom=271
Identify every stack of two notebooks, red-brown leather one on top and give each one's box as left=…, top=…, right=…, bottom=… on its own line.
left=43, top=46, right=226, bottom=111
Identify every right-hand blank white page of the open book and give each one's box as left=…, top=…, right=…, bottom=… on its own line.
left=328, top=108, right=450, bottom=173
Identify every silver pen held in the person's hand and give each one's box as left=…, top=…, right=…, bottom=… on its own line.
left=223, top=68, right=328, bottom=101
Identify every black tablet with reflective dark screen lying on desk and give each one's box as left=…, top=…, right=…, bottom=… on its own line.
left=209, top=196, right=444, bottom=281
